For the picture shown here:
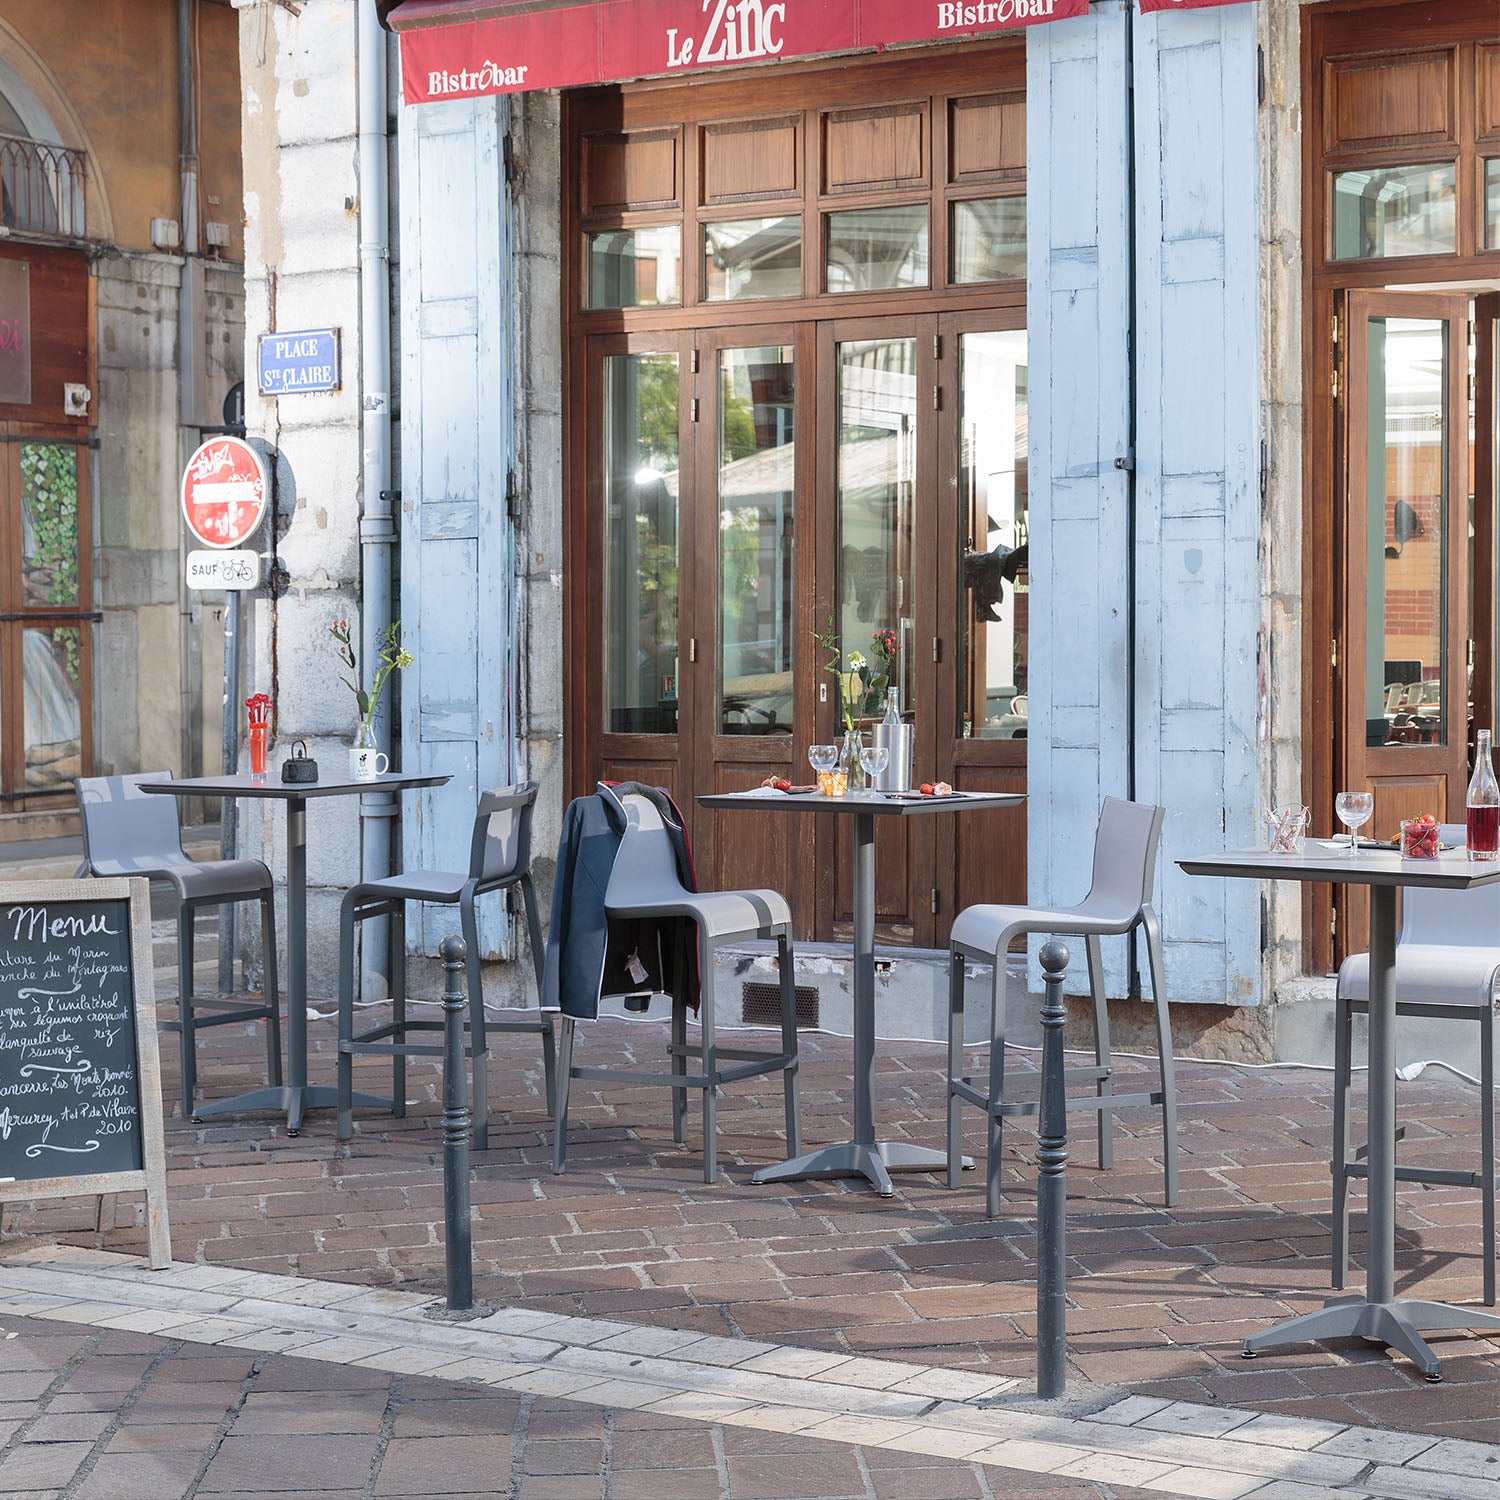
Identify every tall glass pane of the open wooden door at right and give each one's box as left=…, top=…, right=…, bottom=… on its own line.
left=1365, top=318, right=1449, bottom=746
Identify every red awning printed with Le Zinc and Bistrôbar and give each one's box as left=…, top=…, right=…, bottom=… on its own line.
left=390, top=0, right=1092, bottom=104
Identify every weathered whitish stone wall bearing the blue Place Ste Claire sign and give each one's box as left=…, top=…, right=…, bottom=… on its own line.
left=240, top=0, right=370, bottom=995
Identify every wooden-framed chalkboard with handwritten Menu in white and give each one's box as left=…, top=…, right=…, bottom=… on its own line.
left=0, top=879, right=173, bottom=1269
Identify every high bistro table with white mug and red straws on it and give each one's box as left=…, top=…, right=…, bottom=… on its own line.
left=141, top=752, right=449, bottom=1136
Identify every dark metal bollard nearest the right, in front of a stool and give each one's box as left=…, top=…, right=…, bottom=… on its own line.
left=1037, top=942, right=1068, bottom=1401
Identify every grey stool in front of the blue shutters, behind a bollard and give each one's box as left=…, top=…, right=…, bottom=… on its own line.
left=948, top=797, right=1178, bottom=1218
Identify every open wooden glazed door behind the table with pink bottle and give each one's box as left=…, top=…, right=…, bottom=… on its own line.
left=1331, top=293, right=1472, bottom=951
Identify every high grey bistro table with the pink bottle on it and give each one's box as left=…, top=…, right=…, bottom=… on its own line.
left=1178, top=840, right=1500, bottom=1382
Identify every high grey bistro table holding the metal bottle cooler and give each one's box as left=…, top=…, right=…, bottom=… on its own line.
left=698, top=789, right=1025, bottom=1199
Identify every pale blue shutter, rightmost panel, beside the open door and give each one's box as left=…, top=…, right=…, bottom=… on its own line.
left=1134, top=5, right=1262, bottom=1004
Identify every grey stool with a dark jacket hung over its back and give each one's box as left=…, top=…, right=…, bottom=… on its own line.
left=552, top=792, right=803, bottom=1182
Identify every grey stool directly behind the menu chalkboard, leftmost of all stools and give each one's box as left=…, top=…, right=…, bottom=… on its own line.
left=75, top=771, right=282, bottom=1116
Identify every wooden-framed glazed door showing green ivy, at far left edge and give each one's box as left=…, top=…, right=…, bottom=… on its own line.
left=0, top=432, right=99, bottom=810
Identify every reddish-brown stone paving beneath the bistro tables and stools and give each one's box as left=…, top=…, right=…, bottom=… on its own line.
left=6, top=984, right=1500, bottom=1442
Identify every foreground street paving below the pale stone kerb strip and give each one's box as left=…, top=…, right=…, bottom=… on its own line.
left=0, top=1317, right=1145, bottom=1500
